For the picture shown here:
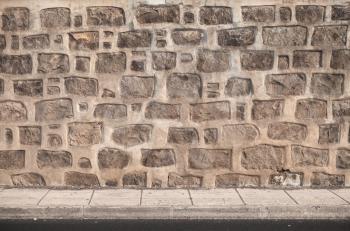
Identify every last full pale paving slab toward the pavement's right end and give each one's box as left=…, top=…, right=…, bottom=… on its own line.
left=287, top=189, right=347, bottom=206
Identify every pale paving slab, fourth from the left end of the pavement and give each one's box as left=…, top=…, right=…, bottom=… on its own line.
left=141, top=189, right=192, bottom=206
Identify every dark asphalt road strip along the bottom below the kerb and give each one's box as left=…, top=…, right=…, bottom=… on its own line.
left=0, top=220, right=350, bottom=231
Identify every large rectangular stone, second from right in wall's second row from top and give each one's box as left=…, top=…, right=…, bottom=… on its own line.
left=262, top=26, right=307, bottom=47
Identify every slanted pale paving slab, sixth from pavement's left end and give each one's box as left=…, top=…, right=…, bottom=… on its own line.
left=237, top=189, right=296, bottom=205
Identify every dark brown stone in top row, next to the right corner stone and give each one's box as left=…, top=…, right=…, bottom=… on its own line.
left=295, top=5, right=326, bottom=24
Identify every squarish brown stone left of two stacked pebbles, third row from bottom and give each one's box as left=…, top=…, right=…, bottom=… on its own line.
left=19, top=126, right=41, bottom=145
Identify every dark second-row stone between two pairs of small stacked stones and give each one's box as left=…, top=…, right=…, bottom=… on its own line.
left=117, top=30, right=152, bottom=48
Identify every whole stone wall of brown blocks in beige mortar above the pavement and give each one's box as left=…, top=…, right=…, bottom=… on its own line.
left=0, top=0, right=350, bottom=188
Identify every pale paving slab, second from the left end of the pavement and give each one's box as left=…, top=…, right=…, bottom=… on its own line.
left=39, top=190, right=93, bottom=206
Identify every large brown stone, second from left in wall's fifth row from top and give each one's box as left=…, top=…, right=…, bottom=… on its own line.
left=35, top=98, right=73, bottom=121
